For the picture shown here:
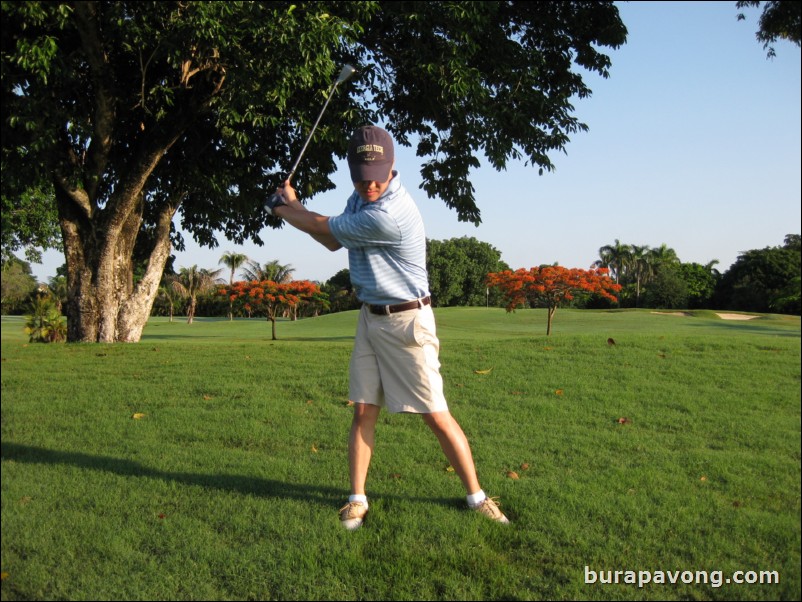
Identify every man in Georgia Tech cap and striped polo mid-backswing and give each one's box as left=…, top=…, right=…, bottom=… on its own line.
left=265, top=126, right=509, bottom=530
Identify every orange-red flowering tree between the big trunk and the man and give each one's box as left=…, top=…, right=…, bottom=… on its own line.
left=218, top=280, right=328, bottom=341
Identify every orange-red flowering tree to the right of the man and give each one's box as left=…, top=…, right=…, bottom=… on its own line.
left=487, top=265, right=621, bottom=335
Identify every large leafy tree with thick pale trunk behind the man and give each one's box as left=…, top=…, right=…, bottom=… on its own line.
left=2, top=1, right=626, bottom=342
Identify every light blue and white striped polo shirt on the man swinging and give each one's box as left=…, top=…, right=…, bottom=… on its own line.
left=329, top=171, right=429, bottom=305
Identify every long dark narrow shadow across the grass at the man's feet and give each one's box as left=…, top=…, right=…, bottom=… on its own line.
left=0, top=442, right=458, bottom=507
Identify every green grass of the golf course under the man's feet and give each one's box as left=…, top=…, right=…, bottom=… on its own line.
left=2, top=308, right=802, bottom=600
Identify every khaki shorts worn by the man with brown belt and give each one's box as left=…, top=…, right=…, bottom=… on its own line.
left=349, top=305, right=448, bottom=414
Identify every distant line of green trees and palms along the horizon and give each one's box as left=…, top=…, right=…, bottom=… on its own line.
left=2, top=234, right=802, bottom=321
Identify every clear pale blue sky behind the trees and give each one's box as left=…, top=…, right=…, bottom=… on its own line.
left=31, top=0, right=802, bottom=281
